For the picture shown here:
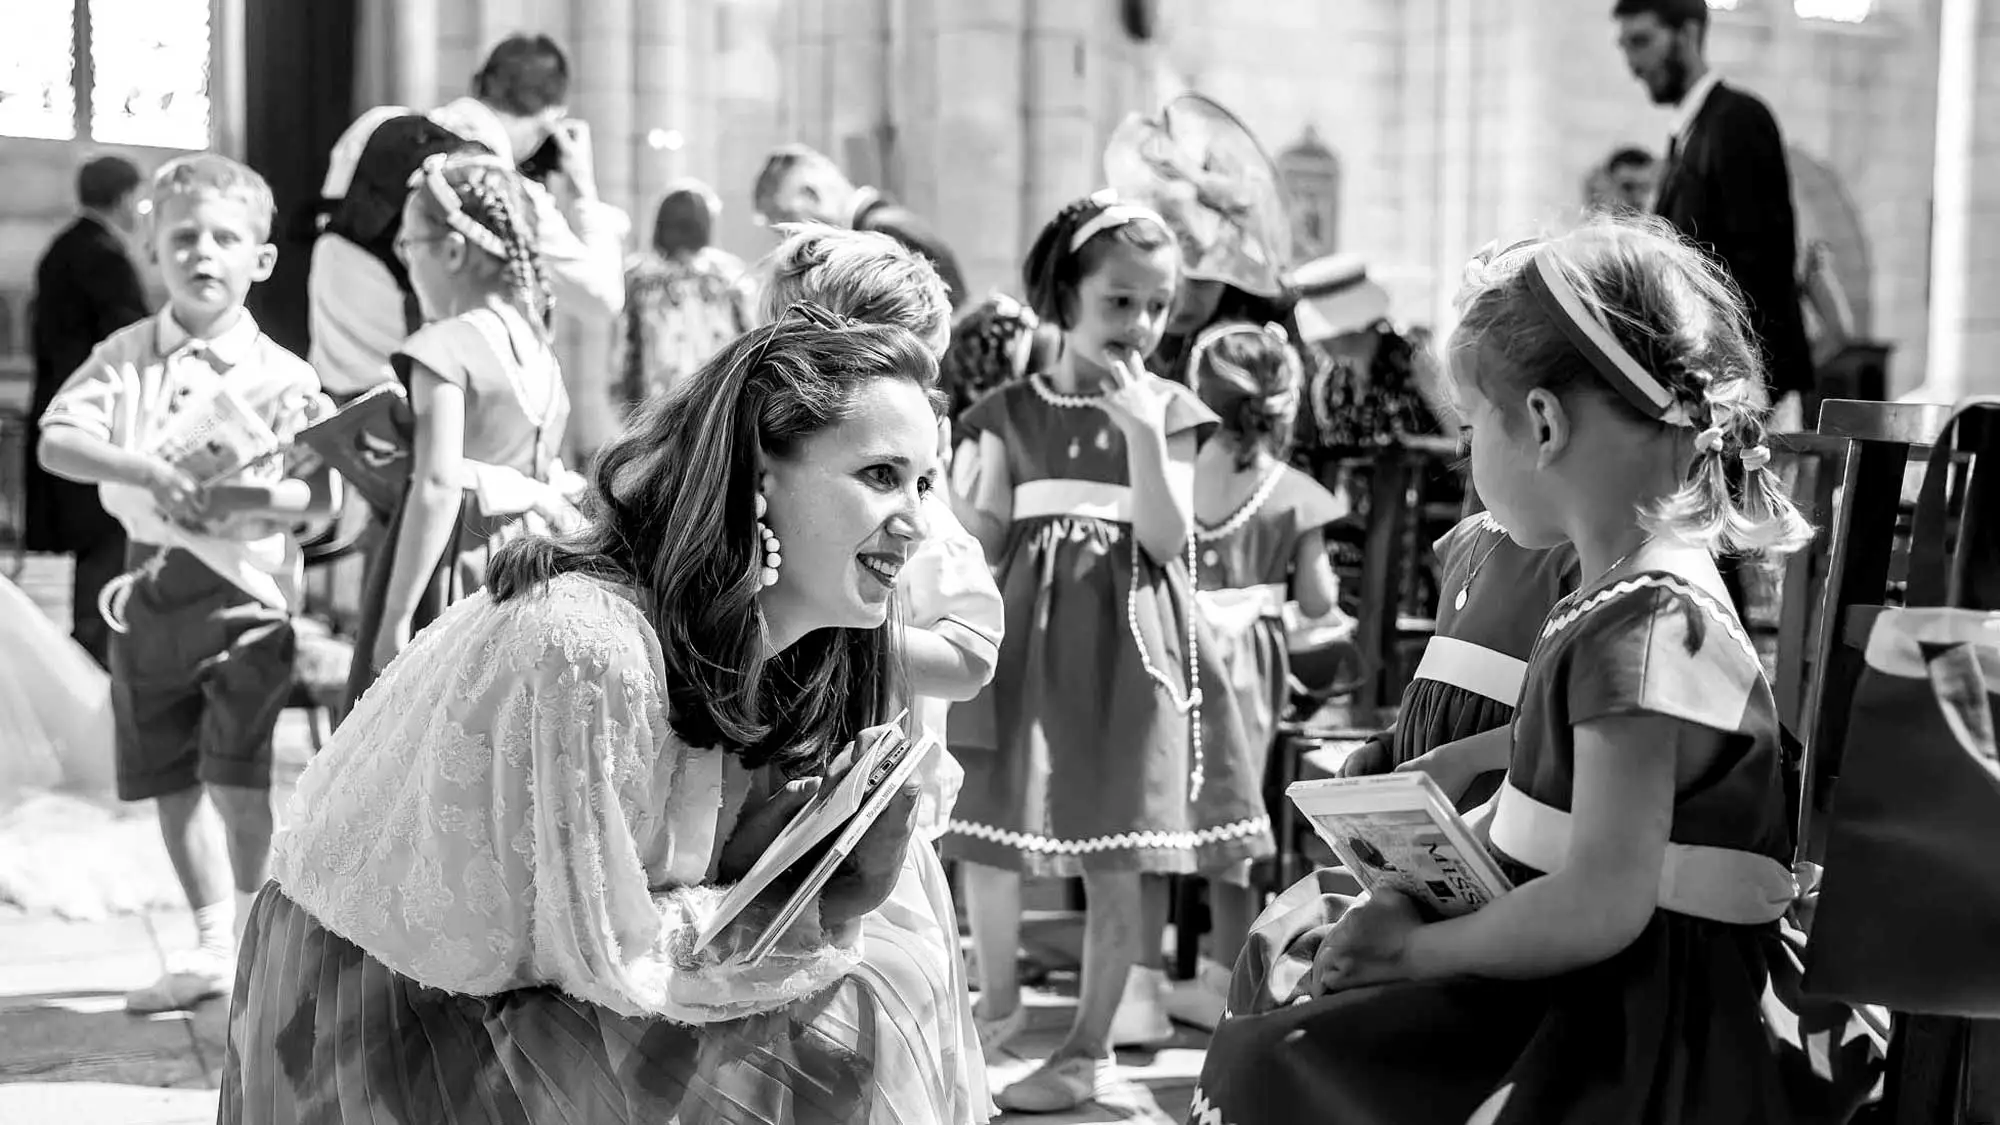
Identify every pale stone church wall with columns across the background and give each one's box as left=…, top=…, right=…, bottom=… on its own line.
left=0, top=0, right=2000, bottom=410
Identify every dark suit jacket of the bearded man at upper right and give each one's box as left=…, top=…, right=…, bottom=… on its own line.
left=1654, top=82, right=1812, bottom=396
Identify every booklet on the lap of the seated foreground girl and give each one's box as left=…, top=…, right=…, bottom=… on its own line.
left=1284, top=771, right=1514, bottom=919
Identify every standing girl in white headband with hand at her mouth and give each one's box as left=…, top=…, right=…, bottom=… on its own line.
left=944, top=188, right=1216, bottom=1113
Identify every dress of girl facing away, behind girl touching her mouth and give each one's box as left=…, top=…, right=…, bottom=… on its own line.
left=1194, top=462, right=1346, bottom=877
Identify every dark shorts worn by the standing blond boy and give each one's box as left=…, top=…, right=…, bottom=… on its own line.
left=112, top=542, right=296, bottom=801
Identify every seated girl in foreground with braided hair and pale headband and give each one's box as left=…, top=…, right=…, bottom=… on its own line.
left=1194, top=220, right=1810, bottom=1125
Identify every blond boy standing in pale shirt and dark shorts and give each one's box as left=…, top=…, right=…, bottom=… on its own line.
left=38, top=154, right=336, bottom=1013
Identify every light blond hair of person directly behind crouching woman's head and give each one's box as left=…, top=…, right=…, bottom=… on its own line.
left=756, top=222, right=952, bottom=356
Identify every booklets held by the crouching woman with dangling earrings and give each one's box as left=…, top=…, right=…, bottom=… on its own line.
left=694, top=719, right=938, bottom=965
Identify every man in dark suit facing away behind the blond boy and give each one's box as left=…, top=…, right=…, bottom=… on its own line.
left=26, top=156, right=146, bottom=665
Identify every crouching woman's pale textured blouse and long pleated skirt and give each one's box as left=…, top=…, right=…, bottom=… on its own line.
left=218, top=575, right=992, bottom=1125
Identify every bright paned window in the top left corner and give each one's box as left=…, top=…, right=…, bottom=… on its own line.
left=0, top=0, right=210, bottom=148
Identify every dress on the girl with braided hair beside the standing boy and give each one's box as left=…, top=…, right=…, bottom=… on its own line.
left=348, top=308, right=570, bottom=707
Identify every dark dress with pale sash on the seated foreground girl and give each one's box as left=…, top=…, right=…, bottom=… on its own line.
left=1190, top=573, right=1832, bottom=1125
